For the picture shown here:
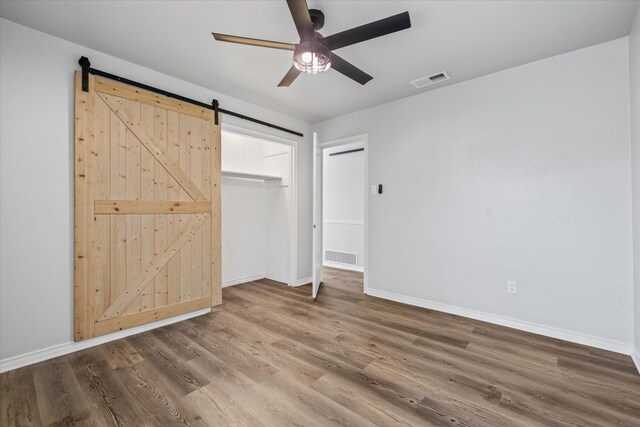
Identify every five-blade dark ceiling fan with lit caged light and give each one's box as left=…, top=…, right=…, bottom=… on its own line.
left=211, top=0, right=411, bottom=87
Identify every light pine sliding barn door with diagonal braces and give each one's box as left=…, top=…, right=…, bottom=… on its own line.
left=75, top=72, right=221, bottom=341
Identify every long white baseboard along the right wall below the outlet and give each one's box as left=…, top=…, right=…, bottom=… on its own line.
left=367, top=288, right=639, bottom=358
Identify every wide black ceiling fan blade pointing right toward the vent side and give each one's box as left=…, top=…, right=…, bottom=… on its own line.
left=323, top=12, right=411, bottom=50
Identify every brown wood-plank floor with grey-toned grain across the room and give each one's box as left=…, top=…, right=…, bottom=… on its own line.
left=0, top=269, right=640, bottom=427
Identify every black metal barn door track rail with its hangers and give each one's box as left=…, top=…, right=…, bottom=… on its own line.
left=78, top=56, right=304, bottom=136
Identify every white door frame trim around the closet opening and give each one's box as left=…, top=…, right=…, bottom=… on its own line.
left=220, top=121, right=300, bottom=286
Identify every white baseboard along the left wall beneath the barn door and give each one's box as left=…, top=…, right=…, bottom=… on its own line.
left=0, top=308, right=211, bottom=373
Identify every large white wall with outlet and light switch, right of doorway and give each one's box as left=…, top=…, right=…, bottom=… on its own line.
left=314, top=37, right=633, bottom=350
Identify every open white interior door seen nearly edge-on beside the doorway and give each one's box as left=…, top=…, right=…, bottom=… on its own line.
left=311, top=132, right=323, bottom=299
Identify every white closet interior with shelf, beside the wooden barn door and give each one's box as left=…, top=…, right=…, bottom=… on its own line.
left=221, top=124, right=296, bottom=288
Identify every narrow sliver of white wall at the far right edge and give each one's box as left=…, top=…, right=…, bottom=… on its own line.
left=629, top=9, right=640, bottom=358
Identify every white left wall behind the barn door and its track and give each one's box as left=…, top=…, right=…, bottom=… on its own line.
left=0, top=19, right=311, bottom=359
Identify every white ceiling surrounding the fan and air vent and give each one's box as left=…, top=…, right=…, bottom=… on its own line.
left=0, top=0, right=638, bottom=123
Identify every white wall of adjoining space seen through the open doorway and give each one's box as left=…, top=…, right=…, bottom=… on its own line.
left=322, top=143, right=365, bottom=270
